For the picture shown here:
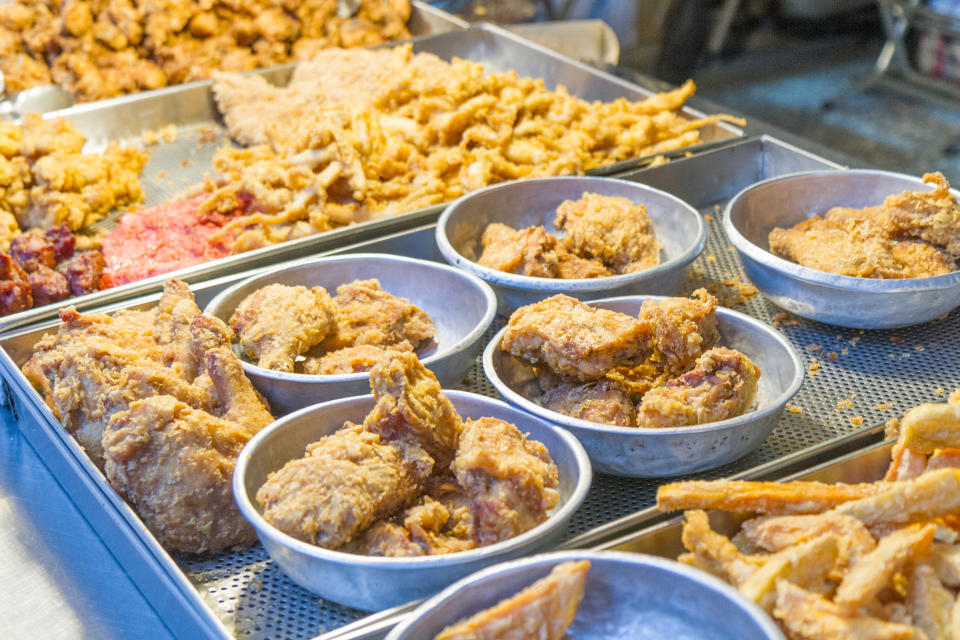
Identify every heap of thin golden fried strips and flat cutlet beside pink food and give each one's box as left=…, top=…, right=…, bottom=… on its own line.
left=204, top=46, right=744, bottom=251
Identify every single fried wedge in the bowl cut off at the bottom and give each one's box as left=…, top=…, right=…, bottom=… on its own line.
left=433, top=560, right=590, bottom=640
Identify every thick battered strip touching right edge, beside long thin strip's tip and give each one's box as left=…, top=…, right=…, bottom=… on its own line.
left=832, top=469, right=960, bottom=527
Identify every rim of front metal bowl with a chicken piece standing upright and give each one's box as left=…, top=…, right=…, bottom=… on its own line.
left=232, top=389, right=593, bottom=570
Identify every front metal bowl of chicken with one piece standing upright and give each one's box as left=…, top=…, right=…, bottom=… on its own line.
left=233, top=391, right=593, bottom=610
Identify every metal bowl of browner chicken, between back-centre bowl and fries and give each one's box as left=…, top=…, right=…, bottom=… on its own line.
left=483, top=296, right=804, bottom=478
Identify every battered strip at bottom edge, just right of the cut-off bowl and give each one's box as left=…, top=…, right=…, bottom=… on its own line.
left=773, top=580, right=916, bottom=640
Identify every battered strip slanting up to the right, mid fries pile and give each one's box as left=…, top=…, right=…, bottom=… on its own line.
left=834, top=524, right=937, bottom=611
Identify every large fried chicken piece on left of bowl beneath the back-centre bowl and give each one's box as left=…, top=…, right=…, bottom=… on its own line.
left=500, top=294, right=650, bottom=381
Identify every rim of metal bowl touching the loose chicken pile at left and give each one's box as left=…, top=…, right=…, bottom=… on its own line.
left=203, top=253, right=497, bottom=384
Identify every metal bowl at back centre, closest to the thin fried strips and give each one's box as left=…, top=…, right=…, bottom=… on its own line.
left=437, top=177, right=707, bottom=314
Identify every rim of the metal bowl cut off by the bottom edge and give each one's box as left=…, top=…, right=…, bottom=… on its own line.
left=386, top=550, right=784, bottom=640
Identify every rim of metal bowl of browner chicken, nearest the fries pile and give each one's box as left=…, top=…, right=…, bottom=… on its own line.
left=483, top=295, right=804, bottom=436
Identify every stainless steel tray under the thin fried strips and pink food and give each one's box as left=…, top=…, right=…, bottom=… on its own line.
left=0, top=20, right=742, bottom=333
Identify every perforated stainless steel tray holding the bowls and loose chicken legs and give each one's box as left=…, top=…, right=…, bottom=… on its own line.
left=0, top=137, right=960, bottom=638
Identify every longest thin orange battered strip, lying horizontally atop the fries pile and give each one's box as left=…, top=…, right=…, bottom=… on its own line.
left=657, top=480, right=890, bottom=514
